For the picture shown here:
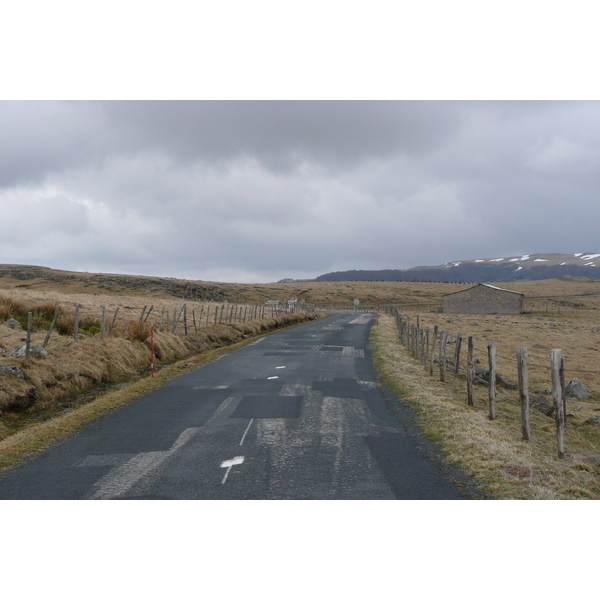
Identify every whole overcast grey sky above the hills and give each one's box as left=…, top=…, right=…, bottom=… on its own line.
left=0, top=101, right=600, bottom=282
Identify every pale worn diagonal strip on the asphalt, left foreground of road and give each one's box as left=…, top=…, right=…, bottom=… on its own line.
left=89, top=427, right=199, bottom=500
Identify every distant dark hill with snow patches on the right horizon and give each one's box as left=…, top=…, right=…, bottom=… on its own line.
left=315, top=252, right=600, bottom=283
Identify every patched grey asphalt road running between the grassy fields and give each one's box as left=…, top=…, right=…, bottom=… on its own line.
left=0, top=313, right=478, bottom=500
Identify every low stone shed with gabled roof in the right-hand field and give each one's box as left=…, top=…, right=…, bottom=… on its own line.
left=442, top=283, right=525, bottom=315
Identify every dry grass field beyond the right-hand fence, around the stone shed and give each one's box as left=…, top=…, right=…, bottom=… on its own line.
left=384, top=280, right=600, bottom=422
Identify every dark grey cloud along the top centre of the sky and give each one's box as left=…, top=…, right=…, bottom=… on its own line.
left=103, top=101, right=459, bottom=170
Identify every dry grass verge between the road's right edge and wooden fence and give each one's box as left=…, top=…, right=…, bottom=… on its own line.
left=371, top=315, right=600, bottom=499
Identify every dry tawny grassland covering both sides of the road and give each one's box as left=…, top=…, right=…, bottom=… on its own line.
left=0, top=271, right=600, bottom=498
